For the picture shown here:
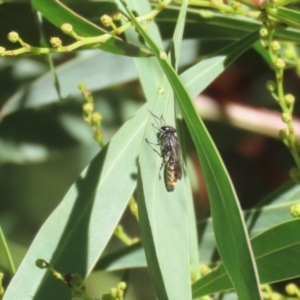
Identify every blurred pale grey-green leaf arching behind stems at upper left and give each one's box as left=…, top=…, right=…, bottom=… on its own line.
left=1, top=51, right=137, bottom=117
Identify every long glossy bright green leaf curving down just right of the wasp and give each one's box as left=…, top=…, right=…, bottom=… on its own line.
left=122, top=1, right=261, bottom=300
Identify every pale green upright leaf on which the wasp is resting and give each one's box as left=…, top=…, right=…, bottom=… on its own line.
left=119, top=1, right=191, bottom=299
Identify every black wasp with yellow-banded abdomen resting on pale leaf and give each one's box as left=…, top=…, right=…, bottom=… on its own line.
left=146, top=112, right=182, bottom=192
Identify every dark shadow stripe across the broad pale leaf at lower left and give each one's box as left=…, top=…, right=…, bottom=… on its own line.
left=33, top=146, right=108, bottom=300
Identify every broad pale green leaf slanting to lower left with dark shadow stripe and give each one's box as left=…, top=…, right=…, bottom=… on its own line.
left=4, top=106, right=148, bottom=300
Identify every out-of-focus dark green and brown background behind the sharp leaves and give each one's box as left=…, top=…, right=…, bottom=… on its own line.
left=0, top=1, right=299, bottom=300
